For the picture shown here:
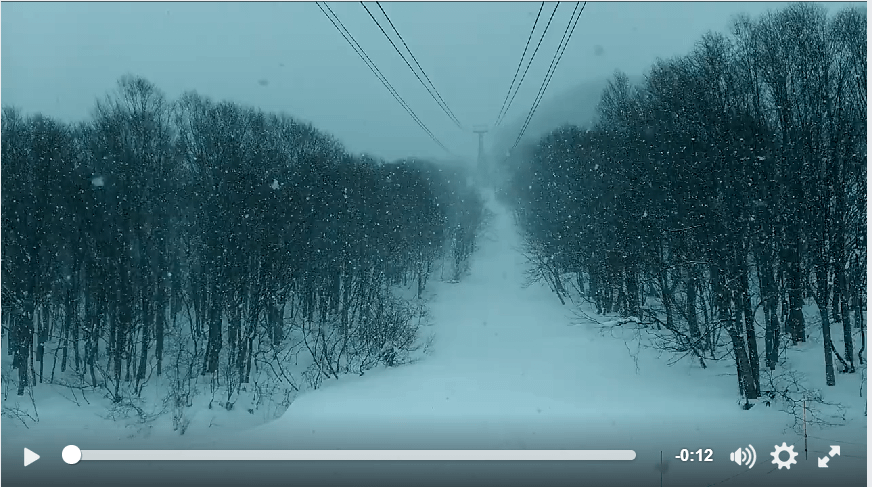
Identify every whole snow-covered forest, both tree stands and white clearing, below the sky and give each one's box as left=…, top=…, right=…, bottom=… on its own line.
left=0, top=3, right=867, bottom=485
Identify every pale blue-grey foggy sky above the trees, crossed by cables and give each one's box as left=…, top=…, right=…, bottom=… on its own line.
left=0, top=2, right=865, bottom=164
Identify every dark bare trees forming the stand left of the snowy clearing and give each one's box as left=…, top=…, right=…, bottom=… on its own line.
left=2, top=77, right=483, bottom=424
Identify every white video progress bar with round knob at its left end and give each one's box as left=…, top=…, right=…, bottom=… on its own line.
left=63, top=445, right=636, bottom=465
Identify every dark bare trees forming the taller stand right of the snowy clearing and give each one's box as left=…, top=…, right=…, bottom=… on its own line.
left=507, top=4, right=866, bottom=399
